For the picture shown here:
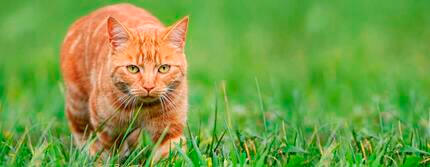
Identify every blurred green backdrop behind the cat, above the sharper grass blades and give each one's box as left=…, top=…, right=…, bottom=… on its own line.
left=0, top=0, right=430, bottom=164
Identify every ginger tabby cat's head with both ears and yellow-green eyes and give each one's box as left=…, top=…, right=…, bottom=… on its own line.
left=107, top=17, right=188, bottom=103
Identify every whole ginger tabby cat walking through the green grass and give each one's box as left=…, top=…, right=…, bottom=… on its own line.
left=61, top=4, right=188, bottom=159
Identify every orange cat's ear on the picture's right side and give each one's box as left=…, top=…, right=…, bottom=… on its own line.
left=164, top=16, right=189, bottom=51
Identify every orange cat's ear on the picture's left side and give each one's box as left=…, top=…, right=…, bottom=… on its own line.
left=107, top=16, right=130, bottom=50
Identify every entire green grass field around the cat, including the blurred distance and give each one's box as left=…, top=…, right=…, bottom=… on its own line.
left=0, top=0, right=430, bottom=166
